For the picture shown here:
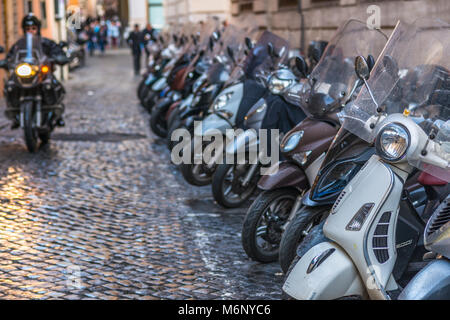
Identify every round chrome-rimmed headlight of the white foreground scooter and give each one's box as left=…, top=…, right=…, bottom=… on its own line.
left=376, top=123, right=410, bottom=162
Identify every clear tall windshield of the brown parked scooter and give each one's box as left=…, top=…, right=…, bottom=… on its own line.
left=300, top=20, right=387, bottom=116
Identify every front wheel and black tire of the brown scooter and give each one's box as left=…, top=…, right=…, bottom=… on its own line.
left=242, top=188, right=300, bottom=263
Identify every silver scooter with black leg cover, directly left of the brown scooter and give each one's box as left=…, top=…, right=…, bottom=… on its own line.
left=212, top=60, right=306, bottom=208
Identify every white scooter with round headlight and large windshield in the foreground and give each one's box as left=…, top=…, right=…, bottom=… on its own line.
left=283, top=20, right=450, bottom=300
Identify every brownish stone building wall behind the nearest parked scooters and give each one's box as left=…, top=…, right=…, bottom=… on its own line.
left=231, top=0, right=450, bottom=49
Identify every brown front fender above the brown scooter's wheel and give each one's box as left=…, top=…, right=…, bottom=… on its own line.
left=258, top=161, right=309, bottom=190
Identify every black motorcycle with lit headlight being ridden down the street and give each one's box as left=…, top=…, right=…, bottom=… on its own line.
left=0, top=34, right=69, bottom=152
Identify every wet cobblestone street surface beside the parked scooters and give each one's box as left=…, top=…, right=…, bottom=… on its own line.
left=0, top=50, right=283, bottom=299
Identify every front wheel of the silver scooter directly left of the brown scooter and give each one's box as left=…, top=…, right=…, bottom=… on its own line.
left=212, top=164, right=257, bottom=208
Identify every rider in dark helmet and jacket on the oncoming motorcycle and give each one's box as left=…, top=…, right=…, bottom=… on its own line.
left=6, top=13, right=69, bottom=129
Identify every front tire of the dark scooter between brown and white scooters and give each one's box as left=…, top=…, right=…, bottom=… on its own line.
left=279, top=206, right=331, bottom=273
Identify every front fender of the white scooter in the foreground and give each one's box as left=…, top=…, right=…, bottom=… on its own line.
left=283, top=242, right=367, bottom=300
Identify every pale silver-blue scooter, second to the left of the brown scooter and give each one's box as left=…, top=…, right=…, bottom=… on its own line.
left=180, top=31, right=289, bottom=186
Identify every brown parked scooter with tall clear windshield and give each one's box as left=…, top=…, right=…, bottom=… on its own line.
left=242, top=20, right=387, bottom=265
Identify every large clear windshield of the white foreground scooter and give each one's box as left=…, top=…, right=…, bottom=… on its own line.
left=341, top=19, right=450, bottom=178
